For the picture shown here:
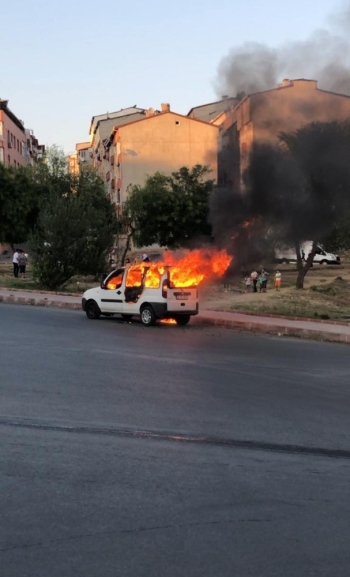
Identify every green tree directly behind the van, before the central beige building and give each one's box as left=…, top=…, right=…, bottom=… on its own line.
left=122, top=165, right=213, bottom=248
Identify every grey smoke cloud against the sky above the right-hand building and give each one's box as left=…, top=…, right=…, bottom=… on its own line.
left=215, top=2, right=350, bottom=96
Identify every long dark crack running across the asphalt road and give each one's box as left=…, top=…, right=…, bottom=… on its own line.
left=0, top=417, right=350, bottom=460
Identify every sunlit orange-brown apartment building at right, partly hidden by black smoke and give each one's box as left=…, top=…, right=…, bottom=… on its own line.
left=215, top=78, right=350, bottom=187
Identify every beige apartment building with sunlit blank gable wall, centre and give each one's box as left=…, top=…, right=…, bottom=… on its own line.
left=101, top=104, right=219, bottom=214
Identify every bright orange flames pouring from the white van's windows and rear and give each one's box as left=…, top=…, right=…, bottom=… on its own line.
left=127, top=249, right=232, bottom=288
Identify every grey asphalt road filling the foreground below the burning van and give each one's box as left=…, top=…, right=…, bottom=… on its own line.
left=0, top=304, right=350, bottom=577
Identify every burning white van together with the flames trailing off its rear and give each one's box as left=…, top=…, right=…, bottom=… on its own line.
left=82, top=250, right=231, bottom=326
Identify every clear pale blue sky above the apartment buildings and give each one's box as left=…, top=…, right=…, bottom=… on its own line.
left=0, top=0, right=346, bottom=153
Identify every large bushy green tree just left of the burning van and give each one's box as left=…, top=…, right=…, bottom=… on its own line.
left=30, top=171, right=117, bottom=290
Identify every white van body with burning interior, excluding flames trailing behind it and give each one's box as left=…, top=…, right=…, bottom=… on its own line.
left=82, top=263, right=198, bottom=326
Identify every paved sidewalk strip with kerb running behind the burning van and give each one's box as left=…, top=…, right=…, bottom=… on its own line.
left=0, top=288, right=350, bottom=343
